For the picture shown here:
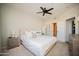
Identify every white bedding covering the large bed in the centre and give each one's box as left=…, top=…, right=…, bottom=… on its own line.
left=21, top=35, right=57, bottom=56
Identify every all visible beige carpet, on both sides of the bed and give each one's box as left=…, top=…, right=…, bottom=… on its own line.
left=8, top=42, right=69, bottom=56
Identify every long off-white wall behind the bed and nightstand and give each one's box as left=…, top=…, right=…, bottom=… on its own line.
left=2, top=6, right=42, bottom=46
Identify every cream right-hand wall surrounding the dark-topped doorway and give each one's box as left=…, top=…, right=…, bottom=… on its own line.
left=58, top=7, right=78, bottom=42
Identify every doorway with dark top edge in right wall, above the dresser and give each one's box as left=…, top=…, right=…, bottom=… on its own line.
left=66, top=17, right=75, bottom=42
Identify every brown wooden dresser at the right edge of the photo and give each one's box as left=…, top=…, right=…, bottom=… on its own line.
left=69, top=34, right=79, bottom=56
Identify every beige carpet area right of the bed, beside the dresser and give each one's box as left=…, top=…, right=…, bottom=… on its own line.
left=48, top=42, right=69, bottom=56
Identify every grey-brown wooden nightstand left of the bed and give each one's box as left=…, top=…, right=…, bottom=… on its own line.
left=8, top=37, right=20, bottom=49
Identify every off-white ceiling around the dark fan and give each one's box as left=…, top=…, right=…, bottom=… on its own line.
left=5, top=3, right=78, bottom=20
